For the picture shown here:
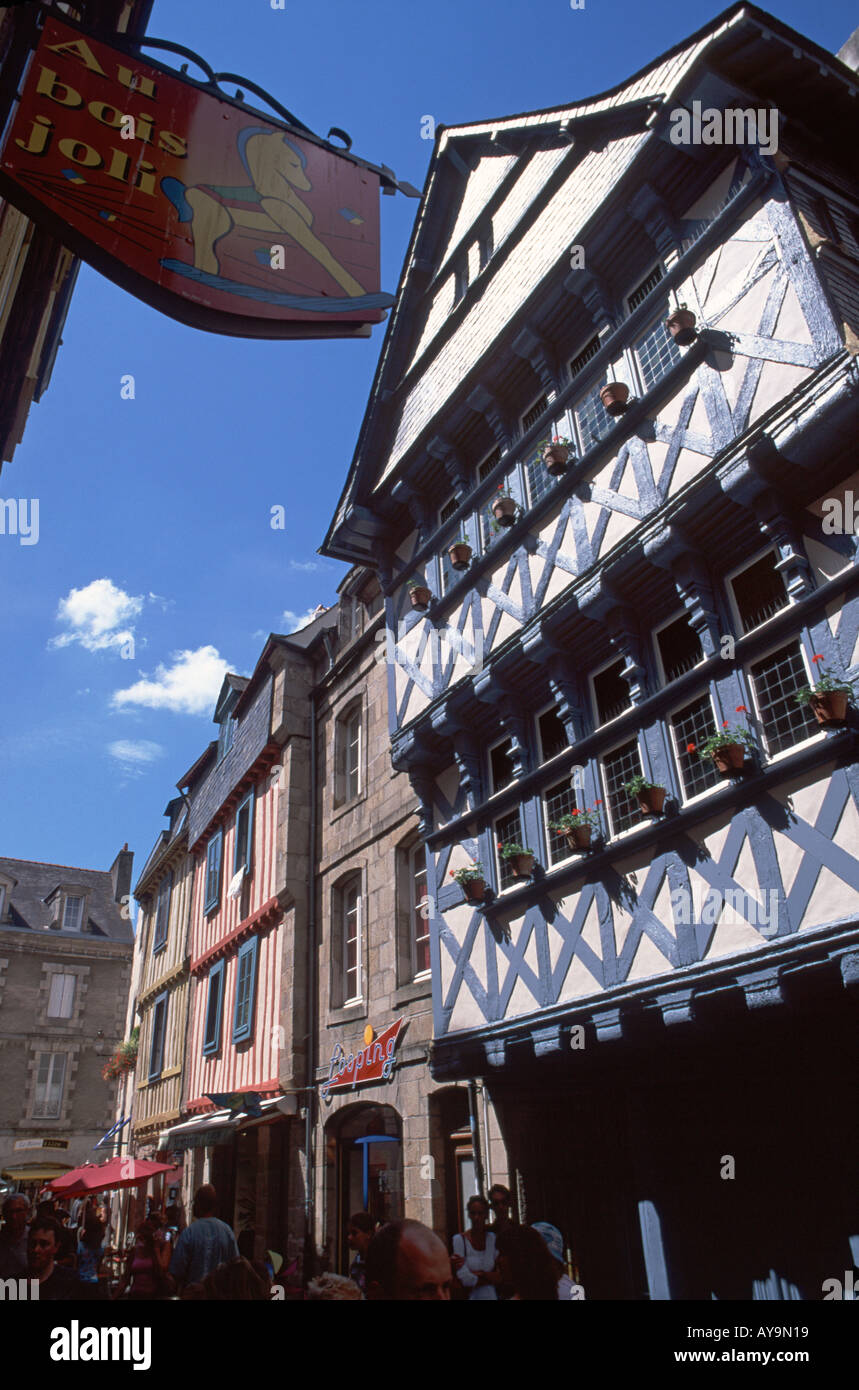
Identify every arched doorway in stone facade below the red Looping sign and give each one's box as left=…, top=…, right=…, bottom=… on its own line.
left=325, top=1105, right=403, bottom=1272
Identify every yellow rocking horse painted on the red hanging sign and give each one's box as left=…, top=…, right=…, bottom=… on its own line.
left=161, top=125, right=364, bottom=297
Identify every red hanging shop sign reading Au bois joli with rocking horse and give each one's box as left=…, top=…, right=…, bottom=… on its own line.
left=0, top=15, right=391, bottom=338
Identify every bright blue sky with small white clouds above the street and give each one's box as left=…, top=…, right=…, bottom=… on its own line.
left=0, top=0, right=856, bottom=870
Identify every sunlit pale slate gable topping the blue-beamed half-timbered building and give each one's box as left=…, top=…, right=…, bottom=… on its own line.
left=320, top=3, right=855, bottom=563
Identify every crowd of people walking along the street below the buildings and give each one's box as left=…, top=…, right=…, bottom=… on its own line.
left=0, top=1184, right=581, bottom=1302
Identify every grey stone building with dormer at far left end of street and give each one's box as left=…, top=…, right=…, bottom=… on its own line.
left=0, top=847, right=133, bottom=1187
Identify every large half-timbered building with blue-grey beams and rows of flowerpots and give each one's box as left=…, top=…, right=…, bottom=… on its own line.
left=322, top=4, right=859, bottom=1298
